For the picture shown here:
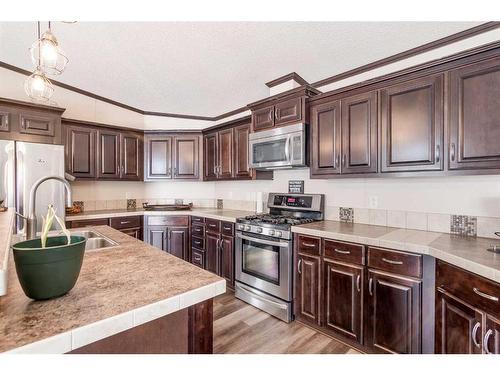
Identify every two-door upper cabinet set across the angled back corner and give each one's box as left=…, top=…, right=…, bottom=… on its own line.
left=145, top=133, right=200, bottom=181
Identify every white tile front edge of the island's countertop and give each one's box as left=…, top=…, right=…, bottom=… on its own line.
left=4, top=280, right=226, bottom=354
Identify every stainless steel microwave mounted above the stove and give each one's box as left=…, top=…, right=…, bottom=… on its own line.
left=248, top=123, right=306, bottom=169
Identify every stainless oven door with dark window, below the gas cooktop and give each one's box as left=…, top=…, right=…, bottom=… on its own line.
left=235, top=231, right=292, bottom=301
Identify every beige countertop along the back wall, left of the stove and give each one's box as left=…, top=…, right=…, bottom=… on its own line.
left=66, top=208, right=255, bottom=223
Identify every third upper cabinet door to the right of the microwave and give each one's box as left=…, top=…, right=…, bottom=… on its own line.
left=380, top=75, right=444, bottom=172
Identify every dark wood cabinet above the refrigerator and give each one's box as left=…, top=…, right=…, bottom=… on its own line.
left=0, top=99, right=64, bottom=144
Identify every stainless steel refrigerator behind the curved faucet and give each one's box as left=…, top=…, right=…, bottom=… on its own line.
left=0, top=140, right=65, bottom=233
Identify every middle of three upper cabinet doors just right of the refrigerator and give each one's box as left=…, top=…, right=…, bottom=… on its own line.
left=97, top=129, right=121, bottom=179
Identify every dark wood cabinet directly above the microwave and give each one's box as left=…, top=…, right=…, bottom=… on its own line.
left=248, top=85, right=319, bottom=132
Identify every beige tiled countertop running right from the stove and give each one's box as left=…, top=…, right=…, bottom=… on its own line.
left=292, top=220, right=500, bottom=283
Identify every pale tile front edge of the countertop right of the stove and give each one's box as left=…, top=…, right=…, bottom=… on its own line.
left=292, top=226, right=500, bottom=283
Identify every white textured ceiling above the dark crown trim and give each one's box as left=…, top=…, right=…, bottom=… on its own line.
left=0, top=22, right=479, bottom=116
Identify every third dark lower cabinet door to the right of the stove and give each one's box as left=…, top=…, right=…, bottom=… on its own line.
left=365, top=270, right=422, bottom=354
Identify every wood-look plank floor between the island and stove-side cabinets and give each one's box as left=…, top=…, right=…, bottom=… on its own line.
left=214, top=292, right=358, bottom=354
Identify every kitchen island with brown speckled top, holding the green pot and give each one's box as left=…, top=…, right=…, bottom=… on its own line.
left=0, top=226, right=226, bottom=353
